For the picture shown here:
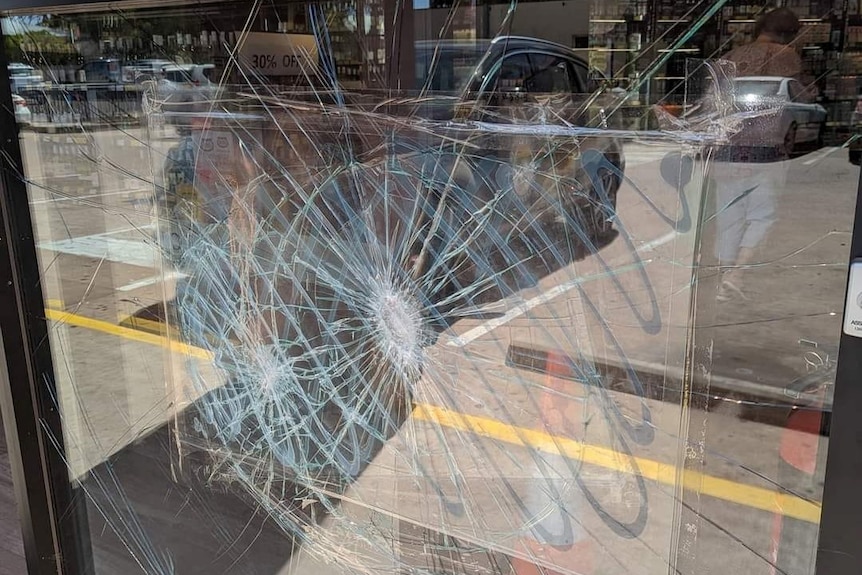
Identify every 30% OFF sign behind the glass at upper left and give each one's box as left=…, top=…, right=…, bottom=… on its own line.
left=237, top=32, right=317, bottom=76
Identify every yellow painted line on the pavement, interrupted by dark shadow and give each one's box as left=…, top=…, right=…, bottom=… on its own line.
left=45, top=309, right=820, bottom=523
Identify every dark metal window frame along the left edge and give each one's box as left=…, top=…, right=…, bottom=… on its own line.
left=0, top=20, right=93, bottom=575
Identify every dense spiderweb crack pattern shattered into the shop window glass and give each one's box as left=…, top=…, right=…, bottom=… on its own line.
left=149, top=19, right=734, bottom=573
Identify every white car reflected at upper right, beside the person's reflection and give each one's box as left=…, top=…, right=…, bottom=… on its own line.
left=734, top=76, right=826, bottom=155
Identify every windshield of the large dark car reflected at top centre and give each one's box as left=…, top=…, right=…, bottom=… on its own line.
left=416, top=43, right=488, bottom=92
